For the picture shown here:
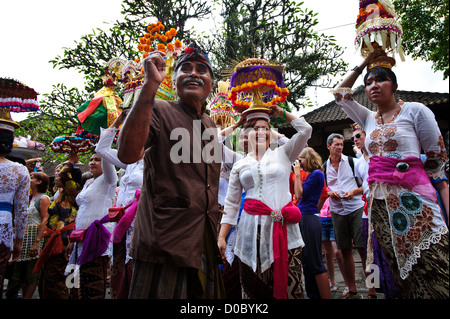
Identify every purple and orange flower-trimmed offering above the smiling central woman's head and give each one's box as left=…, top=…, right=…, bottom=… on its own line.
left=229, top=58, right=289, bottom=116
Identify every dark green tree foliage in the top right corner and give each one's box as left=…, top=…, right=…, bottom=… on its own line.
left=394, top=0, right=449, bottom=79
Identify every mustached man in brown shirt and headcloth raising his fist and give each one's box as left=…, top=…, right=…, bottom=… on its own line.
left=118, top=43, right=224, bottom=298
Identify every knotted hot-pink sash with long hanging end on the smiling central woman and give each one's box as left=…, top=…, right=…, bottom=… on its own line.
left=244, top=198, right=301, bottom=299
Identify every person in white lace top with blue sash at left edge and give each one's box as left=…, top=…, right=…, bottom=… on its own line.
left=0, top=120, right=30, bottom=299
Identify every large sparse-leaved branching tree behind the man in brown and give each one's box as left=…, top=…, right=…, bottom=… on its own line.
left=21, top=0, right=346, bottom=165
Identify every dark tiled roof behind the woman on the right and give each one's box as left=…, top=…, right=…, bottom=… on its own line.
left=304, top=86, right=449, bottom=126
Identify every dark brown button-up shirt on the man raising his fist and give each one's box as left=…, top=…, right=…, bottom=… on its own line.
left=130, top=100, right=221, bottom=269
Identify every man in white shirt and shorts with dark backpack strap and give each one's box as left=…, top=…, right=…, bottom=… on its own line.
left=324, top=133, right=364, bottom=299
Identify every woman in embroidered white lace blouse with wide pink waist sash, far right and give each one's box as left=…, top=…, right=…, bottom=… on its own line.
left=333, top=47, right=449, bottom=299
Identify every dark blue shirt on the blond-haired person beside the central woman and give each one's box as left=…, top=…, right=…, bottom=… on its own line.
left=298, top=169, right=325, bottom=215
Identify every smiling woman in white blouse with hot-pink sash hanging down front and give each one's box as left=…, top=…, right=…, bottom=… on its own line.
left=218, top=106, right=312, bottom=298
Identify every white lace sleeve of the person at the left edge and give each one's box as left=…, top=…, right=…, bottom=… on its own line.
left=14, top=165, right=30, bottom=238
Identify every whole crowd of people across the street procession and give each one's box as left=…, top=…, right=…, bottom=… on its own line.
left=0, top=43, right=449, bottom=299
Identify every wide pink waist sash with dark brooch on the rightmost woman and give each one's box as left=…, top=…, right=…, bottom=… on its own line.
left=367, top=156, right=437, bottom=201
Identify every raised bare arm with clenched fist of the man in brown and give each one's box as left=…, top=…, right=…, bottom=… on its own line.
left=117, top=51, right=166, bottom=164
